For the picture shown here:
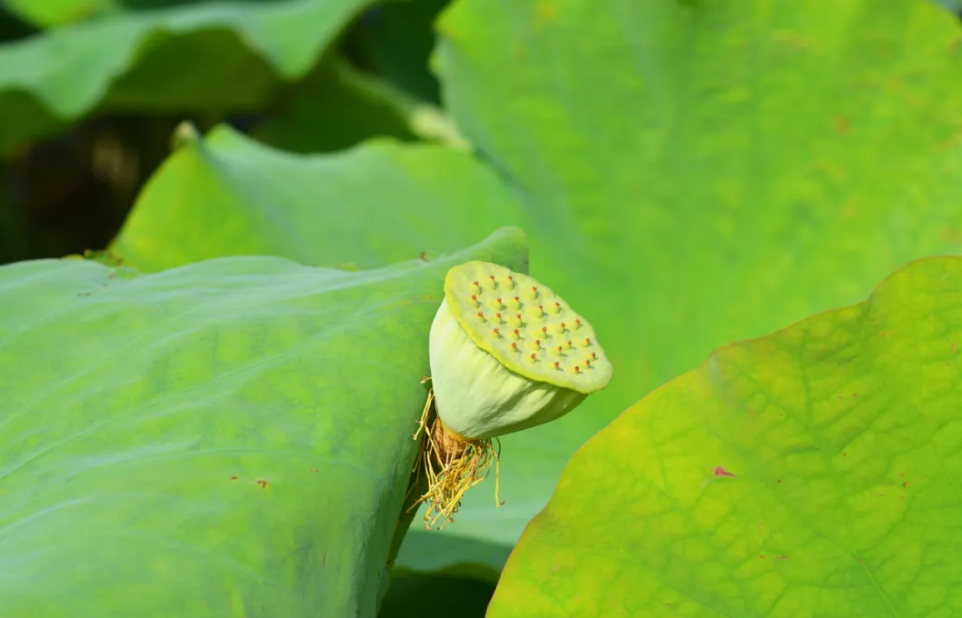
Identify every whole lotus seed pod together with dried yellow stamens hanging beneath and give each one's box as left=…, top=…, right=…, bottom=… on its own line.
left=414, top=262, right=612, bottom=528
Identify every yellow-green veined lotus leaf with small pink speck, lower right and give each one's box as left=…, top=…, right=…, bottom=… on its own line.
left=488, top=257, right=962, bottom=618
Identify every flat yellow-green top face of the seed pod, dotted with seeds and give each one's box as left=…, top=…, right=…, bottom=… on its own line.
left=444, top=261, right=612, bottom=394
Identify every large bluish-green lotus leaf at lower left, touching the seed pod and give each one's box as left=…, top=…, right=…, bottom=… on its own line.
left=0, top=230, right=527, bottom=618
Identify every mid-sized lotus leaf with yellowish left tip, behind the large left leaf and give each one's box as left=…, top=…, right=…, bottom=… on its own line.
left=112, top=126, right=502, bottom=271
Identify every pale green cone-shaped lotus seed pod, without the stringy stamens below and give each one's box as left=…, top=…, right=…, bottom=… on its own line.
left=430, top=262, right=612, bottom=440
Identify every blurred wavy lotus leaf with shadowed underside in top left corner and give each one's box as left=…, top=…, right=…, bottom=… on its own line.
left=0, top=0, right=366, bottom=153
